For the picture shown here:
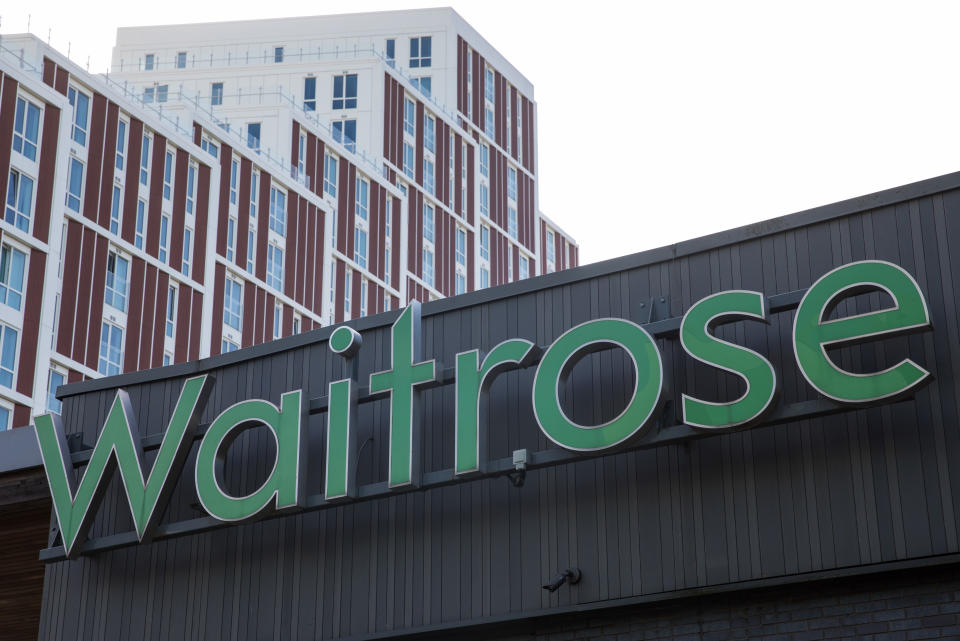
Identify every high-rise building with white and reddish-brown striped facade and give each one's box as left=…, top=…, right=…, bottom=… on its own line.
left=0, top=9, right=577, bottom=429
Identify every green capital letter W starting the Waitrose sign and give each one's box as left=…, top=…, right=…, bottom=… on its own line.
left=34, top=375, right=210, bottom=558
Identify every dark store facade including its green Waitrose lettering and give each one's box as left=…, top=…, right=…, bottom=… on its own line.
left=0, top=174, right=960, bottom=639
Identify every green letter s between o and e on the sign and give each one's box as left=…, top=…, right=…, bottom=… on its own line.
left=680, top=290, right=777, bottom=428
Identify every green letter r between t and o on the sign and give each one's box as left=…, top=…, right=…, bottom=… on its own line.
left=453, top=338, right=537, bottom=474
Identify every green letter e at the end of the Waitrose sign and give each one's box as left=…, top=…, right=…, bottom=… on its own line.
left=793, top=260, right=930, bottom=403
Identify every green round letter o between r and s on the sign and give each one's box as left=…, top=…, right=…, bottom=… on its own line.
left=533, top=318, right=663, bottom=452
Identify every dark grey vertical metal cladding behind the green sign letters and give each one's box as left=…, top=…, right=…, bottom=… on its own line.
left=41, top=179, right=960, bottom=639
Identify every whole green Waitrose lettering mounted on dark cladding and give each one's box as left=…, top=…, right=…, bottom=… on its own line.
left=34, top=261, right=930, bottom=557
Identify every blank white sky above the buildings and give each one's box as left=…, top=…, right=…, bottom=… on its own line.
left=0, top=0, right=960, bottom=263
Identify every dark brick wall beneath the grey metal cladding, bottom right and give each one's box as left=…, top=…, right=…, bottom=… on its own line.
left=485, top=565, right=960, bottom=641
